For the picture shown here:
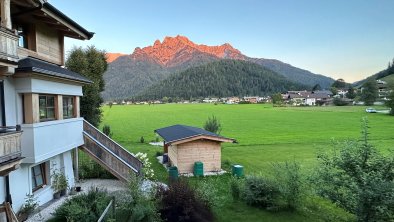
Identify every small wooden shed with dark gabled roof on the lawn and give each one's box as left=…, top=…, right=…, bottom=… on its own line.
left=155, top=125, right=235, bottom=174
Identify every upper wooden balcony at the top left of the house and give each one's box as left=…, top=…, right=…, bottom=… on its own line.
left=0, top=27, right=19, bottom=63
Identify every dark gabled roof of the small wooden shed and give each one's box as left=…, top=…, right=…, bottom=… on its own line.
left=155, top=125, right=235, bottom=143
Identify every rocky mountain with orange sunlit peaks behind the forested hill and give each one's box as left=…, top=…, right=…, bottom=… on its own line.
left=103, top=35, right=334, bottom=100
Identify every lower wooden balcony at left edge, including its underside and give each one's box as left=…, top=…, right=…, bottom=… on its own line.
left=0, top=126, right=22, bottom=176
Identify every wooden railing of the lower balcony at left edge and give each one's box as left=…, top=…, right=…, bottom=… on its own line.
left=0, top=126, right=22, bottom=163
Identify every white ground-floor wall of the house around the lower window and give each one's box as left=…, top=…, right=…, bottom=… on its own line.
left=0, top=151, right=75, bottom=211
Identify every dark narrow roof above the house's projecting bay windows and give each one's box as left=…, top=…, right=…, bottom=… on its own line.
left=15, top=57, right=93, bottom=83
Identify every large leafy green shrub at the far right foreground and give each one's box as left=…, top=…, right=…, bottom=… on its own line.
left=314, top=119, right=394, bottom=221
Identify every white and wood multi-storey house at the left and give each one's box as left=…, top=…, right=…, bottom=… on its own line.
left=0, top=0, right=93, bottom=215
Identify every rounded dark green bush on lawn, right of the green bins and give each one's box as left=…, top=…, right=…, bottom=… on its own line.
left=242, top=176, right=279, bottom=209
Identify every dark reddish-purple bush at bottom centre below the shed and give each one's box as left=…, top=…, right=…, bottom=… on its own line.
left=158, top=180, right=214, bottom=222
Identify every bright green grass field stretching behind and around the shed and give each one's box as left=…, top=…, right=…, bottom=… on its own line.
left=102, top=104, right=394, bottom=221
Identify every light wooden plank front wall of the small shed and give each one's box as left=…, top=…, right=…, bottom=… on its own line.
left=176, top=140, right=221, bottom=173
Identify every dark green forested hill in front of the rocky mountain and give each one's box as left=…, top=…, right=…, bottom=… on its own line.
left=135, top=60, right=306, bottom=100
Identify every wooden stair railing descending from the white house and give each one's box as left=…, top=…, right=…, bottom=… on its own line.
left=81, top=120, right=143, bottom=181
